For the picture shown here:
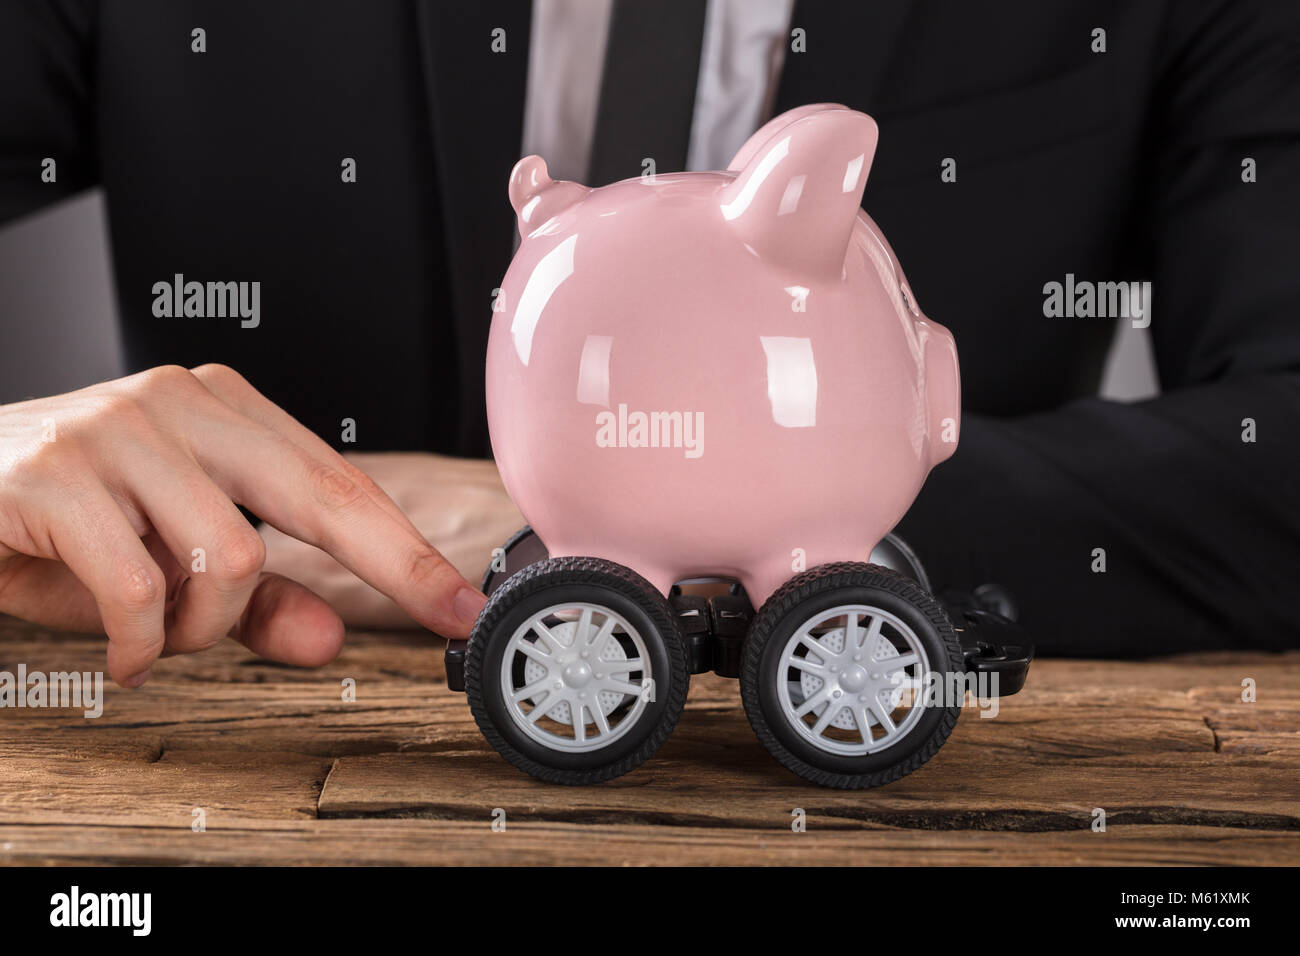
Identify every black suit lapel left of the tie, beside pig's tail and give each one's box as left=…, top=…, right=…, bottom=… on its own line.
left=413, top=0, right=532, bottom=455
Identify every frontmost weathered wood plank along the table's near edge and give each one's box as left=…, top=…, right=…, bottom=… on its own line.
left=0, top=819, right=1300, bottom=866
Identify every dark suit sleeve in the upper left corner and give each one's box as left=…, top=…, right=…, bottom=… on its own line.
left=0, top=0, right=98, bottom=222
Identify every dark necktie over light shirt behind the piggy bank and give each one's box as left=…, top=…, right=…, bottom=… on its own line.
left=586, top=0, right=707, bottom=186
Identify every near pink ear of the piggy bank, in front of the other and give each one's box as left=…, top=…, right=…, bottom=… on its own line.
left=719, top=107, right=878, bottom=274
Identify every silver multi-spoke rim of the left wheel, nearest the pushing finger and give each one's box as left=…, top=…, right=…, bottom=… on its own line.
left=501, top=601, right=654, bottom=753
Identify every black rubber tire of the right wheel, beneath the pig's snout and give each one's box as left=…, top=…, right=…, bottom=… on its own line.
left=740, top=562, right=966, bottom=790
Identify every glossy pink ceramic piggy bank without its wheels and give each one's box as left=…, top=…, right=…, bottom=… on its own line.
left=488, top=104, right=959, bottom=606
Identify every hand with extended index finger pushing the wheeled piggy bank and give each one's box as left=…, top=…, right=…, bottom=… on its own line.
left=0, top=365, right=484, bottom=687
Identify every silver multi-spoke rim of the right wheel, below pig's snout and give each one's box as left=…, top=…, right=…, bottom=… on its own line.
left=776, top=605, right=930, bottom=757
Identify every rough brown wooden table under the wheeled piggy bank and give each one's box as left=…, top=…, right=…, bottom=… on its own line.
left=0, top=617, right=1300, bottom=864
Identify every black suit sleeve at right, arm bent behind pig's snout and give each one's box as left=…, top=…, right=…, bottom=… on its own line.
left=898, top=1, right=1300, bottom=656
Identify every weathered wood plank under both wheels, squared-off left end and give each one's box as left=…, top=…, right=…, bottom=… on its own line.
left=319, top=744, right=1300, bottom=831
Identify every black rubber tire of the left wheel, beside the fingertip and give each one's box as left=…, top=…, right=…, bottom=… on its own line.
left=465, top=558, right=690, bottom=786
